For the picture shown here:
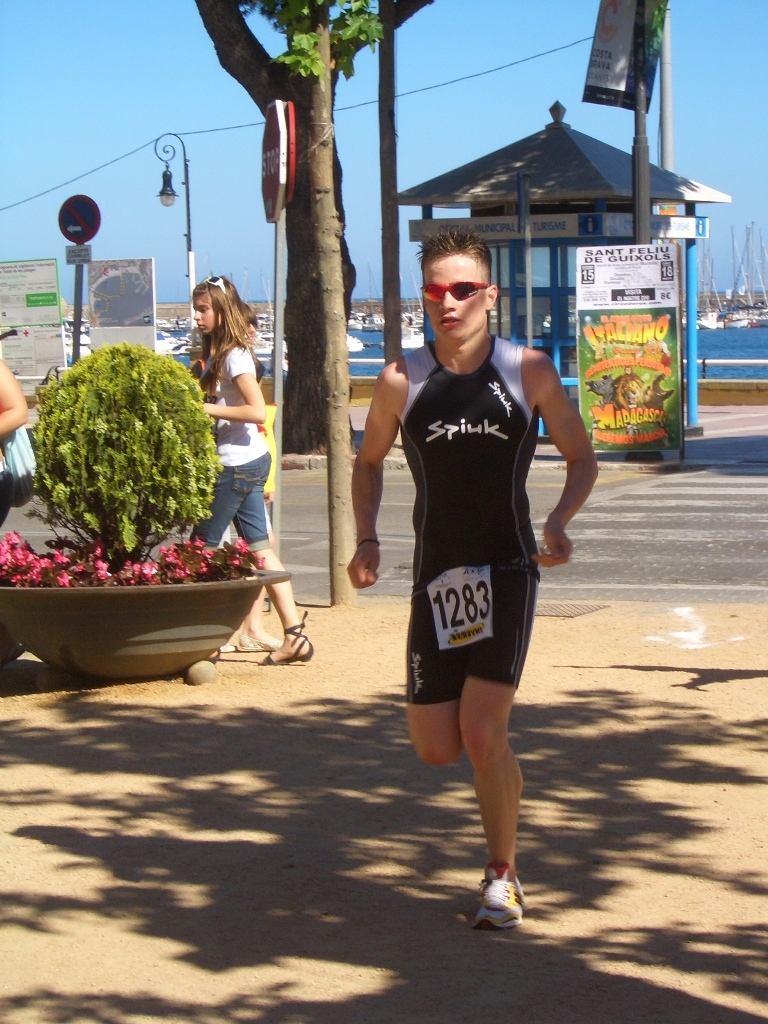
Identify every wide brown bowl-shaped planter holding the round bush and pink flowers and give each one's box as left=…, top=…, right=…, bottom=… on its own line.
left=0, top=571, right=290, bottom=679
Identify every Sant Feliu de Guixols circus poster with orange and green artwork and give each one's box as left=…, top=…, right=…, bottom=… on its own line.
left=577, top=243, right=683, bottom=452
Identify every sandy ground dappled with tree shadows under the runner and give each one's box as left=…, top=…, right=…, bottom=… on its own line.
left=0, top=603, right=768, bottom=1024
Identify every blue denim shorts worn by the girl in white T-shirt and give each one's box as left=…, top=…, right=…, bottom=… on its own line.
left=193, top=452, right=272, bottom=551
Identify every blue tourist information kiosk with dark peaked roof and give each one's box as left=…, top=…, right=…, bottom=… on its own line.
left=398, top=103, right=731, bottom=434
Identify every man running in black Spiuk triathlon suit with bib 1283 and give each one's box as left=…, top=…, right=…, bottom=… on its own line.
left=348, top=228, right=597, bottom=929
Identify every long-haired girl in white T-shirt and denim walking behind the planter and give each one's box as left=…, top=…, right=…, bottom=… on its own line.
left=193, top=278, right=314, bottom=665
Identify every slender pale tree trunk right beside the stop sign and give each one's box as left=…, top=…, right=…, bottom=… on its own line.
left=309, top=3, right=355, bottom=605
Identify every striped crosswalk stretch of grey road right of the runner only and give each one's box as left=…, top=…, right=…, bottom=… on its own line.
left=542, top=470, right=768, bottom=604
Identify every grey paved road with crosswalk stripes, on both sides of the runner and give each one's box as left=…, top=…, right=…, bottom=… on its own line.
left=282, top=468, right=768, bottom=604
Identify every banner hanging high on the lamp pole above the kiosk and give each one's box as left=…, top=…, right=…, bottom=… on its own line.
left=582, top=0, right=668, bottom=113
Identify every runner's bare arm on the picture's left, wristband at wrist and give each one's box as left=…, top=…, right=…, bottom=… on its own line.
left=347, top=360, right=408, bottom=590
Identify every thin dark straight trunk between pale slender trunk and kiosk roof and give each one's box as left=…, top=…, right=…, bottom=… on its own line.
left=379, top=0, right=402, bottom=362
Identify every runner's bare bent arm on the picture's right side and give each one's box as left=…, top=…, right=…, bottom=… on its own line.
left=523, top=349, right=597, bottom=568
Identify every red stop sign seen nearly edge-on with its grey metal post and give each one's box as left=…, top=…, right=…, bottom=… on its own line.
left=261, top=99, right=296, bottom=556
